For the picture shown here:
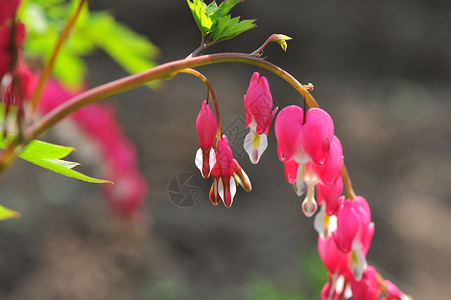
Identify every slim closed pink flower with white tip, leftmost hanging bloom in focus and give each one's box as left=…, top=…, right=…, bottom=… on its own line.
left=195, top=100, right=216, bottom=178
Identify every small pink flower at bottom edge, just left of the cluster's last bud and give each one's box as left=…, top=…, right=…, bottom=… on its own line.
left=351, top=266, right=381, bottom=300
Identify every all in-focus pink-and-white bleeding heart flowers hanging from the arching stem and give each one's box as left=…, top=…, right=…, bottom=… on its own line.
left=196, top=73, right=408, bottom=300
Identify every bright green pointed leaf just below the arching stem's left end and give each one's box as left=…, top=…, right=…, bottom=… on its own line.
left=0, top=132, right=111, bottom=183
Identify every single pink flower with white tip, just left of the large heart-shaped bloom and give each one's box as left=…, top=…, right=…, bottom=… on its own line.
left=244, top=72, right=277, bottom=164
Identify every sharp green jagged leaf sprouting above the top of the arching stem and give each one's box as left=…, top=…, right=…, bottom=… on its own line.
left=187, top=0, right=257, bottom=42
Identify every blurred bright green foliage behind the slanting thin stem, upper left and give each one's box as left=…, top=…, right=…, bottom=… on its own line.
left=20, top=0, right=158, bottom=89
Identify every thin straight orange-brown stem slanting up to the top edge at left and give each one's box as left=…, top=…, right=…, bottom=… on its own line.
left=31, top=0, right=88, bottom=113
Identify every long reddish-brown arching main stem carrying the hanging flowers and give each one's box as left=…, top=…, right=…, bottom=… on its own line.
left=0, top=53, right=319, bottom=174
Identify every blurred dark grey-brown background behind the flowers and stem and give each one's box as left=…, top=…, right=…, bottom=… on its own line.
left=0, top=0, right=451, bottom=300
